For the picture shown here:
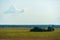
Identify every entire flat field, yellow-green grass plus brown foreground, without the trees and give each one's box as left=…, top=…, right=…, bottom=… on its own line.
left=0, top=28, right=60, bottom=40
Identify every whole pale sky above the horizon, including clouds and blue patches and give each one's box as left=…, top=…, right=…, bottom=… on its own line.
left=0, top=0, right=60, bottom=25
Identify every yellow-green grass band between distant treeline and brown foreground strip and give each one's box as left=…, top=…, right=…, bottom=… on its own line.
left=0, top=28, right=60, bottom=37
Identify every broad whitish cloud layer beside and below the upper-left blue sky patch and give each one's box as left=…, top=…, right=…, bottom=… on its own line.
left=0, top=0, right=60, bottom=24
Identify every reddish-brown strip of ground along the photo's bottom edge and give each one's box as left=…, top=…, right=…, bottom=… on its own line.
left=0, top=36, right=60, bottom=40
